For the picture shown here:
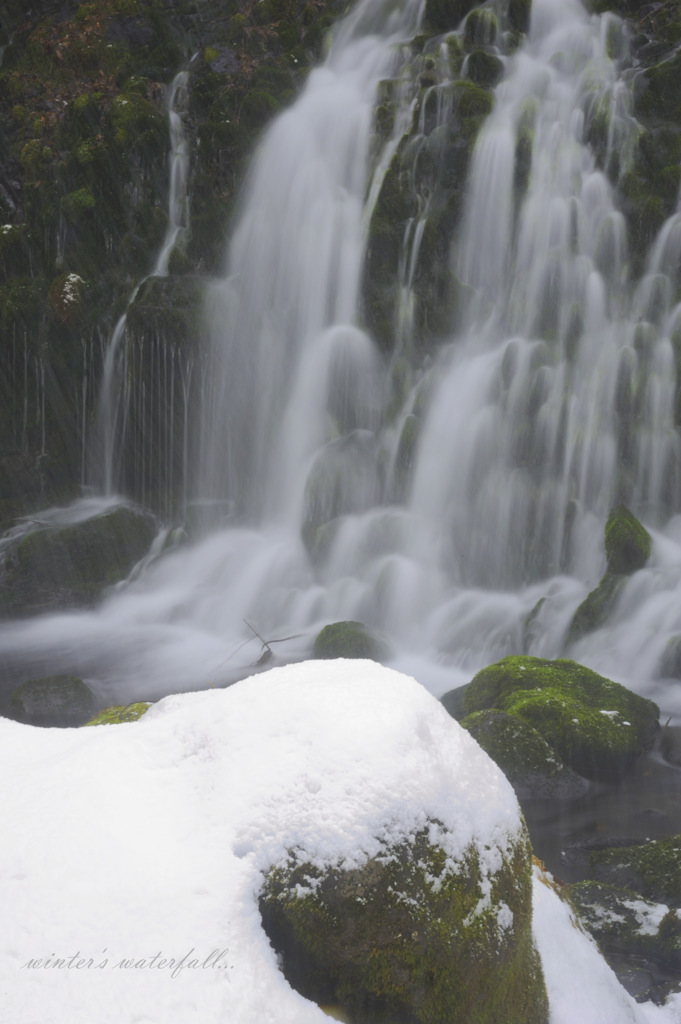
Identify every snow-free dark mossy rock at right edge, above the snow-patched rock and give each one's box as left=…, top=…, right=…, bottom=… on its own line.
left=589, top=835, right=681, bottom=908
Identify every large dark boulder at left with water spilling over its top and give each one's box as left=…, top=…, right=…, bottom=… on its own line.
left=0, top=506, right=157, bottom=615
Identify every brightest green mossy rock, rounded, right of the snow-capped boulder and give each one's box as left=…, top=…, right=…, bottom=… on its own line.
left=464, top=655, right=659, bottom=778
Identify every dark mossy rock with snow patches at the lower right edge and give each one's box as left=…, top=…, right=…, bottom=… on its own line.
left=567, top=881, right=681, bottom=970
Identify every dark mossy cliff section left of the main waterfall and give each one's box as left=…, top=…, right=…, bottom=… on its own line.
left=0, top=0, right=339, bottom=523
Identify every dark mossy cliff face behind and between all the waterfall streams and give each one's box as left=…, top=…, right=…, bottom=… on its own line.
left=0, top=0, right=681, bottom=524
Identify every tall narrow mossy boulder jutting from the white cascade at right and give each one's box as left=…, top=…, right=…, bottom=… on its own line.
left=566, top=505, right=652, bottom=645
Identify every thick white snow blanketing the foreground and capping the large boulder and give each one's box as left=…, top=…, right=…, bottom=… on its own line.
left=0, top=662, right=681, bottom=1024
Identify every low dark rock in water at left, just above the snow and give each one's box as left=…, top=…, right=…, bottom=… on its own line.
left=6, top=676, right=95, bottom=728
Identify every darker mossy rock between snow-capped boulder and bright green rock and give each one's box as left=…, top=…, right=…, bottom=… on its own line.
left=461, top=709, right=589, bottom=801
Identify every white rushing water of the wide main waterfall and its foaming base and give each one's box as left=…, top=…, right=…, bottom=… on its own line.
left=0, top=0, right=681, bottom=715
